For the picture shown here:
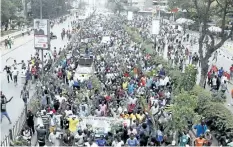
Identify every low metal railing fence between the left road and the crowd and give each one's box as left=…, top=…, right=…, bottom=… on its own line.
left=1, top=11, right=95, bottom=146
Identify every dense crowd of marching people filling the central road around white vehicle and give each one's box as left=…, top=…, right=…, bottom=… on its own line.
left=1, top=6, right=233, bottom=147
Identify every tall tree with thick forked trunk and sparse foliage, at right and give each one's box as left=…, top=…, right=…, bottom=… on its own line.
left=169, top=0, right=233, bottom=86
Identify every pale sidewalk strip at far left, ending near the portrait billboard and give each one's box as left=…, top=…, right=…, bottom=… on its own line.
left=0, top=34, right=33, bottom=56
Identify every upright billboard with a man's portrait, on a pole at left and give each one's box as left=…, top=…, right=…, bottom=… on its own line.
left=34, top=19, right=50, bottom=49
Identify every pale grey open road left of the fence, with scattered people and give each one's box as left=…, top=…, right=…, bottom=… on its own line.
left=0, top=16, right=73, bottom=140
